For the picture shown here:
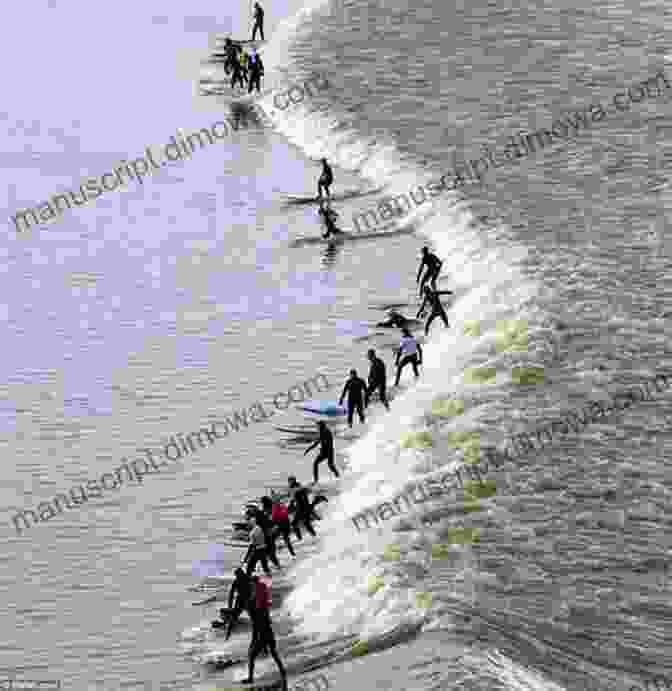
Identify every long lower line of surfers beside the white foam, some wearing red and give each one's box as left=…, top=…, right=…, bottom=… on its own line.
left=206, top=247, right=450, bottom=691
